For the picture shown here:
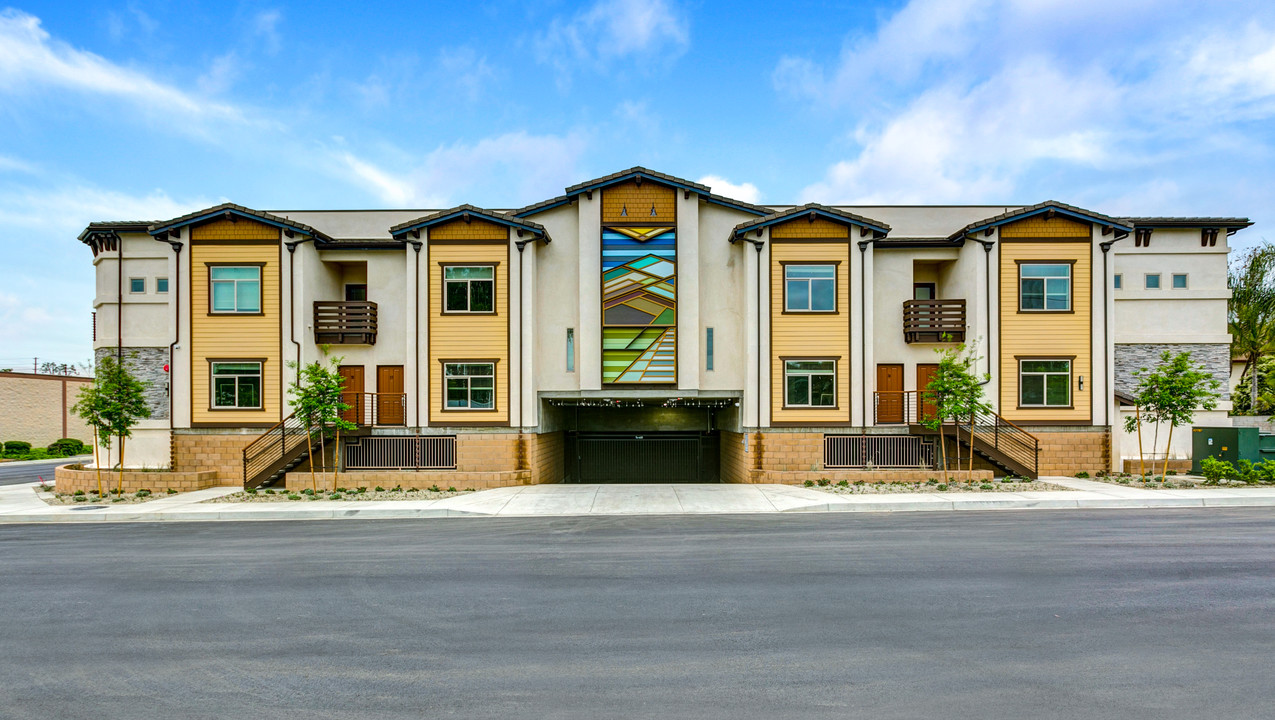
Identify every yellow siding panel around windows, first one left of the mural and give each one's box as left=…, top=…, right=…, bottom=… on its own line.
left=428, top=243, right=509, bottom=426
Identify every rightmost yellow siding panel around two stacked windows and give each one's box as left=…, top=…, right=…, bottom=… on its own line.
left=1000, top=242, right=1093, bottom=424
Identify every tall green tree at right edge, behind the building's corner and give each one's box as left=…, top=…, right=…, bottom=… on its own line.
left=1227, top=243, right=1275, bottom=413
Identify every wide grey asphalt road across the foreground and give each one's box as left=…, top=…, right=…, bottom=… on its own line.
left=0, top=508, right=1275, bottom=720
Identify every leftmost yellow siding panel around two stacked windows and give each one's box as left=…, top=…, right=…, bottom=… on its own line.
left=190, top=238, right=281, bottom=424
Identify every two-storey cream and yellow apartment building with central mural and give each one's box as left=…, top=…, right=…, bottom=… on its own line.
left=80, top=167, right=1251, bottom=487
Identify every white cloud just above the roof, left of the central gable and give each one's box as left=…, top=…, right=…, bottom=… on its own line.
left=333, top=133, right=588, bottom=208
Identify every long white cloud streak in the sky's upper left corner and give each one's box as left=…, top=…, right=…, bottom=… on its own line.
left=0, top=9, right=246, bottom=130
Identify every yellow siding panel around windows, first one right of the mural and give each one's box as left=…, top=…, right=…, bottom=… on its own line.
left=770, top=243, right=850, bottom=426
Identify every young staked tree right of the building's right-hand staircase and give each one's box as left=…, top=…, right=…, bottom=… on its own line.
left=1125, top=350, right=1221, bottom=482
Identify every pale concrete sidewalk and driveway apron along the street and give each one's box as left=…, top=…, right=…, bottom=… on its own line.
left=0, top=478, right=1275, bottom=524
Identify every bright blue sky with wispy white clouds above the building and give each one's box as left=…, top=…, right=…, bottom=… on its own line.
left=0, top=0, right=1275, bottom=367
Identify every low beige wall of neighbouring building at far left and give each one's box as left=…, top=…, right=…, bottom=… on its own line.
left=0, top=372, right=93, bottom=447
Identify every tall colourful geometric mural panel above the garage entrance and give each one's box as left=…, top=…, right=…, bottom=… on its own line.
left=602, top=227, right=677, bottom=384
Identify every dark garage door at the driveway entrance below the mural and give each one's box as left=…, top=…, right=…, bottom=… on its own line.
left=567, top=432, right=719, bottom=483
